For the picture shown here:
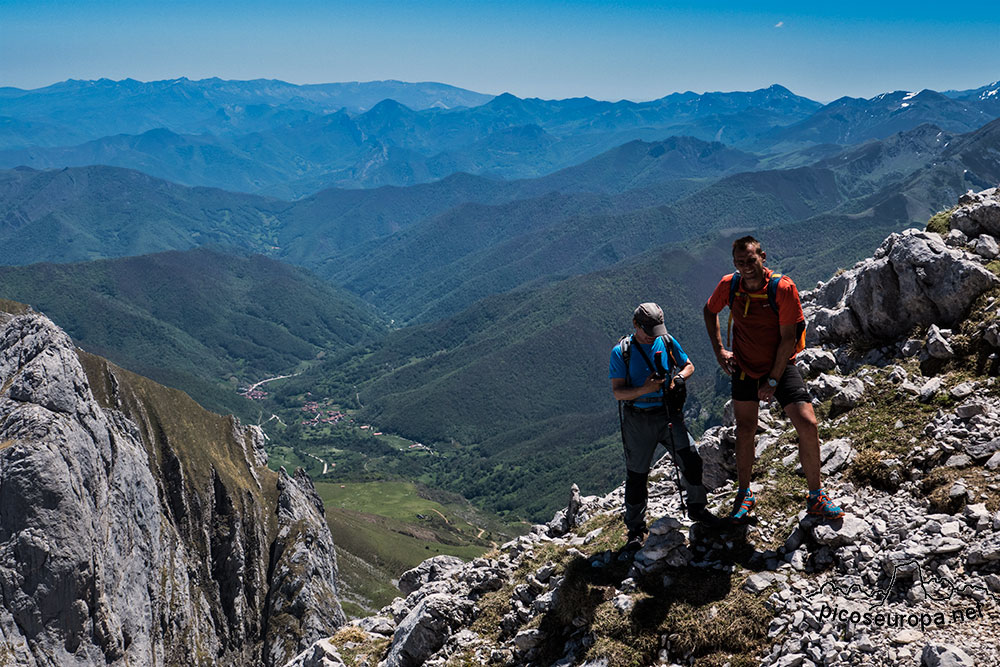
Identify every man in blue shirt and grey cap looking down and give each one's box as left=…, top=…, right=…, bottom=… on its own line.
left=608, top=302, right=717, bottom=550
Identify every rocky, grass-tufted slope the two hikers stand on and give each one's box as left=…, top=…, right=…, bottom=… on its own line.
left=289, top=190, right=1000, bottom=667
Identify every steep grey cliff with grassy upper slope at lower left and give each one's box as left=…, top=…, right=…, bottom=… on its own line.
left=0, top=313, right=343, bottom=665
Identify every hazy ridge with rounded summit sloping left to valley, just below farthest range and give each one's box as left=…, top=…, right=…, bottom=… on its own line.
left=248, top=138, right=756, bottom=266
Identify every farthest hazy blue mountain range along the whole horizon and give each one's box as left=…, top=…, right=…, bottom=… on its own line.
left=0, top=79, right=1000, bottom=199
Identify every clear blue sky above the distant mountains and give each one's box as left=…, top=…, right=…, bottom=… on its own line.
left=0, top=0, right=1000, bottom=101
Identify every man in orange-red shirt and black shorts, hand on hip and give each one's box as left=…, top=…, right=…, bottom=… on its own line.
left=704, top=236, right=844, bottom=521
